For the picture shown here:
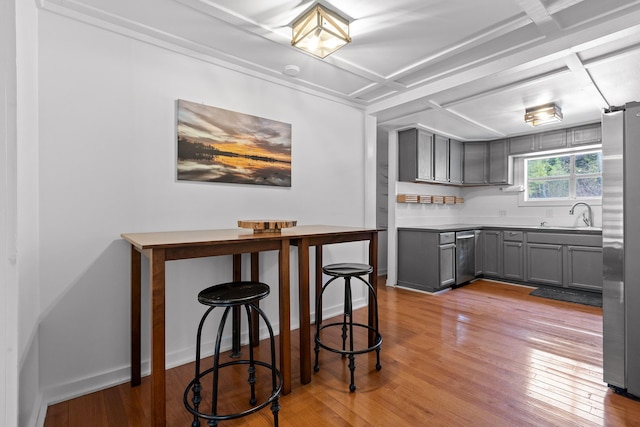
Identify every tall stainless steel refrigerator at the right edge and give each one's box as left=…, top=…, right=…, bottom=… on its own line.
left=602, top=102, right=640, bottom=397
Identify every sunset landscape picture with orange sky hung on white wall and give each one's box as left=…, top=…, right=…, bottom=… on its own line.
left=177, top=100, right=291, bottom=187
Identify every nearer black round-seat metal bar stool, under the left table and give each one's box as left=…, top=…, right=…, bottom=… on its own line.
left=184, top=282, right=282, bottom=427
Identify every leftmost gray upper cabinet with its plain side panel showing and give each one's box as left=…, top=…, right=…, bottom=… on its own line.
left=398, top=129, right=433, bottom=182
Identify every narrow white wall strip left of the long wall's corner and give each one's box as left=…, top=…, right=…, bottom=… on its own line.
left=13, top=1, right=42, bottom=426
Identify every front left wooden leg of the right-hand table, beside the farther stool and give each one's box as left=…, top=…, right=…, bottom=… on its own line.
left=298, top=238, right=311, bottom=384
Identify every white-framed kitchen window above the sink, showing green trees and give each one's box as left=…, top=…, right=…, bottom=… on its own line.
left=522, top=150, right=602, bottom=204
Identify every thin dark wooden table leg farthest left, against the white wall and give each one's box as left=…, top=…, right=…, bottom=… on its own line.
left=131, top=245, right=142, bottom=387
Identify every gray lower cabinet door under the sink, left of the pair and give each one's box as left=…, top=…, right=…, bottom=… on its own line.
left=527, top=243, right=563, bottom=286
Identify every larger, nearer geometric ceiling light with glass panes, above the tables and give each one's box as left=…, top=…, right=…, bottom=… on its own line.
left=291, top=3, right=351, bottom=58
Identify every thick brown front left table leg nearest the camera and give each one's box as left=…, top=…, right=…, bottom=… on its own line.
left=149, top=249, right=167, bottom=427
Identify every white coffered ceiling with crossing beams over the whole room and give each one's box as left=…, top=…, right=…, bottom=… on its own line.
left=38, top=0, right=640, bottom=140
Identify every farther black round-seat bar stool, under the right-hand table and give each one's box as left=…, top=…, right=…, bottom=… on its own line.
left=313, top=263, right=382, bottom=392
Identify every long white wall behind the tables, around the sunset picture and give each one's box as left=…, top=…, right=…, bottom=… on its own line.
left=21, top=6, right=375, bottom=422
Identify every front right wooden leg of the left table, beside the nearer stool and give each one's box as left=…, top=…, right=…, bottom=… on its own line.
left=278, top=239, right=291, bottom=394
